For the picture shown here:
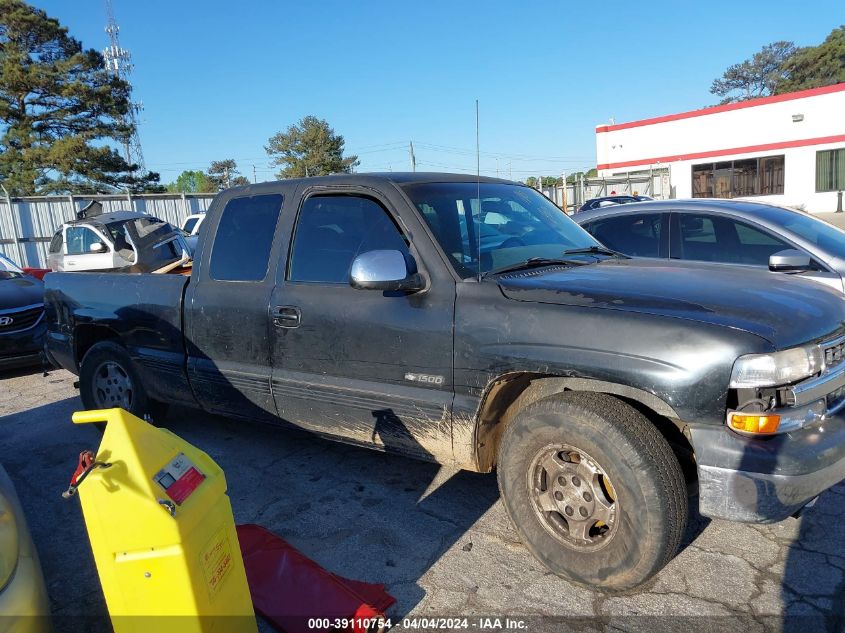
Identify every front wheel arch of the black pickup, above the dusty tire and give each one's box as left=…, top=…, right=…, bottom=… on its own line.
left=473, top=372, right=692, bottom=472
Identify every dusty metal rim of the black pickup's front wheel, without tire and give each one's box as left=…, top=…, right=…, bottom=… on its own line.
left=528, top=444, right=619, bottom=551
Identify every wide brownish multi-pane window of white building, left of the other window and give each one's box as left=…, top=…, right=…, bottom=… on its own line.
left=692, top=156, right=784, bottom=198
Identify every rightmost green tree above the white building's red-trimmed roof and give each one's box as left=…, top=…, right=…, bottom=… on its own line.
left=775, top=25, right=845, bottom=94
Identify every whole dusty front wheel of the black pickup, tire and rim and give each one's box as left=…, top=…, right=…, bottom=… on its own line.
left=498, top=392, right=687, bottom=592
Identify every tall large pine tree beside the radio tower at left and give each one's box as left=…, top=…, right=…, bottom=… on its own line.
left=0, top=0, right=159, bottom=195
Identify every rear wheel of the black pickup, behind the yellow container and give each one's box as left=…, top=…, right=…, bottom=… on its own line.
left=79, top=341, right=166, bottom=429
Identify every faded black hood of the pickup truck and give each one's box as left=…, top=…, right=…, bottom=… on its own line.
left=498, top=259, right=845, bottom=349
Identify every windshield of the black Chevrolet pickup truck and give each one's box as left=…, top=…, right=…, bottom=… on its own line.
left=403, top=182, right=599, bottom=278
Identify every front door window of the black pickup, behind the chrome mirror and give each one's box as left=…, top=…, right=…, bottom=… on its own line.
left=288, top=196, right=408, bottom=284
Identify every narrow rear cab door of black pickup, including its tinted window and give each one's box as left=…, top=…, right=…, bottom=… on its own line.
left=185, top=193, right=285, bottom=419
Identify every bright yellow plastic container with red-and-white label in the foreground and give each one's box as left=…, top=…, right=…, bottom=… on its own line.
left=73, top=409, right=257, bottom=633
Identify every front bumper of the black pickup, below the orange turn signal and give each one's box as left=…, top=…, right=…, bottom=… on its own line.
left=690, top=414, right=845, bottom=523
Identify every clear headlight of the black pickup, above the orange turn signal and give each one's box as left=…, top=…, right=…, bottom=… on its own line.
left=731, top=345, right=824, bottom=389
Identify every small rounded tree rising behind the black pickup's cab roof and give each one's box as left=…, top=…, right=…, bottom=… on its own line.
left=264, top=116, right=359, bottom=178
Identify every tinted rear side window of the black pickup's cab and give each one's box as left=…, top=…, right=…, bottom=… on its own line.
left=209, top=193, right=283, bottom=281
